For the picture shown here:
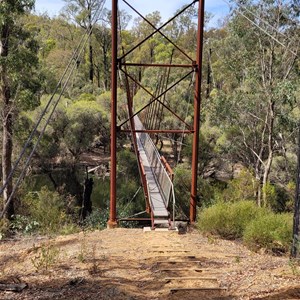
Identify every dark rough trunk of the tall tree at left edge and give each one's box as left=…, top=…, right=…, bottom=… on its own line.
left=0, top=24, right=14, bottom=218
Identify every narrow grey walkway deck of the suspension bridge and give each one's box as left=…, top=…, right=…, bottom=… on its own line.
left=134, top=117, right=169, bottom=217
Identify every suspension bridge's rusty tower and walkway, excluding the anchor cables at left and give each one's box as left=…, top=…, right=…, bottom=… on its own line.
left=108, top=0, right=204, bottom=228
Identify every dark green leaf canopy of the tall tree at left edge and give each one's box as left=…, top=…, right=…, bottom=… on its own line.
left=0, top=13, right=43, bottom=111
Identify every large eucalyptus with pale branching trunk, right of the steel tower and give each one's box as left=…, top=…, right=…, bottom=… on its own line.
left=213, top=0, right=299, bottom=206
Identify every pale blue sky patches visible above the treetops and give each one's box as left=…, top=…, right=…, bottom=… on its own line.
left=35, top=0, right=229, bottom=27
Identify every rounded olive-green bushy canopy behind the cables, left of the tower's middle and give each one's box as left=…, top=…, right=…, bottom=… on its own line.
left=22, top=94, right=109, bottom=163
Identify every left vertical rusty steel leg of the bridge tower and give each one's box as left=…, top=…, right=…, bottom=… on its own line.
left=107, top=0, right=118, bottom=228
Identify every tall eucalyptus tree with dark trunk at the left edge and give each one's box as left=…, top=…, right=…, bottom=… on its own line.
left=0, top=0, right=40, bottom=218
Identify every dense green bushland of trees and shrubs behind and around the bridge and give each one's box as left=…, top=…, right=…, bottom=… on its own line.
left=0, top=0, right=300, bottom=246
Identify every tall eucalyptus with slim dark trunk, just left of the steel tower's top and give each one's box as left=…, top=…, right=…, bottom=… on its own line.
left=63, top=0, right=105, bottom=82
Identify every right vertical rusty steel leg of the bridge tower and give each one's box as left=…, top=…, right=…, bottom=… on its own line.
left=190, top=0, right=204, bottom=223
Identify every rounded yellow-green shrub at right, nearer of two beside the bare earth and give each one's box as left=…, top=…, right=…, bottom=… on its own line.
left=243, top=213, right=293, bottom=253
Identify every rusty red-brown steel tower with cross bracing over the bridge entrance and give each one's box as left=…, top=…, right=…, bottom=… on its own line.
left=108, top=0, right=204, bottom=228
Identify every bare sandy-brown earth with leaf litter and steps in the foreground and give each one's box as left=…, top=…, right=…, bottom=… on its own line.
left=0, top=228, right=300, bottom=300
